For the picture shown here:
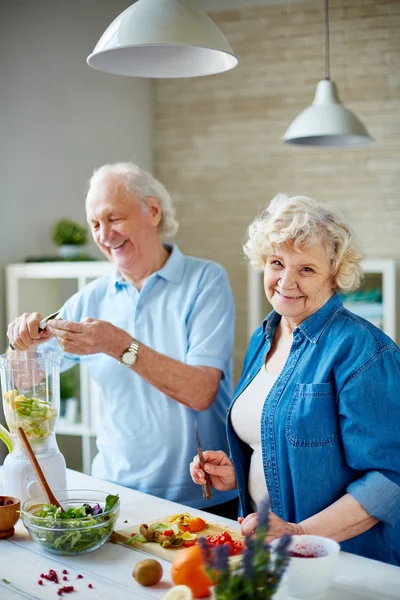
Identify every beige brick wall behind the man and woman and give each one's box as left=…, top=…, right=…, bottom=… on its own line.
left=156, top=0, right=400, bottom=378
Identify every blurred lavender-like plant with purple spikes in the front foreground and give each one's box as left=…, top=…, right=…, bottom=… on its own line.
left=199, top=499, right=292, bottom=600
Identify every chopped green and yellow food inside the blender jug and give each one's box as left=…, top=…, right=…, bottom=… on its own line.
left=4, top=390, right=56, bottom=440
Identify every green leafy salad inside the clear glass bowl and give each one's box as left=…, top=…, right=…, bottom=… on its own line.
left=25, top=495, right=119, bottom=554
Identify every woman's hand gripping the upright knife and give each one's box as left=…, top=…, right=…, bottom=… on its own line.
left=190, top=450, right=237, bottom=492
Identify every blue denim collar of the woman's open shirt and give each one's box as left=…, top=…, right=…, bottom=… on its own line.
left=263, top=292, right=343, bottom=344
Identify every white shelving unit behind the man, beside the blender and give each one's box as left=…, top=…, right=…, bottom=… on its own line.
left=6, top=261, right=113, bottom=473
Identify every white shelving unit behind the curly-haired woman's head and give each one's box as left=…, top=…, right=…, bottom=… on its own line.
left=247, top=259, right=396, bottom=341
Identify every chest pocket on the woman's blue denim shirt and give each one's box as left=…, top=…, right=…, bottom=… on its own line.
left=286, top=383, right=339, bottom=447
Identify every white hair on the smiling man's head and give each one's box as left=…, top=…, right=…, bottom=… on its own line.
left=88, top=162, right=179, bottom=237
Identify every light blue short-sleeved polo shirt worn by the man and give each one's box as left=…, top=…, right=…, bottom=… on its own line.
left=46, top=245, right=237, bottom=508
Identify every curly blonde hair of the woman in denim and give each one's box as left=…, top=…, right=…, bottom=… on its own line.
left=243, top=194, right=362, bottom=293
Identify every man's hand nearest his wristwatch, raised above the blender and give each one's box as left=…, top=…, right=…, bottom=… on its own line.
left=47, top=317, right=132, bottom=359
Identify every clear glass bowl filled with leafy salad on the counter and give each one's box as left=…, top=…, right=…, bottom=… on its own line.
left=21, top=490, right=120, bottom=556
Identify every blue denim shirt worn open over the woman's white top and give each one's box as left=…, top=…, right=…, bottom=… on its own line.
left=227, top=293, right=400, bottom=564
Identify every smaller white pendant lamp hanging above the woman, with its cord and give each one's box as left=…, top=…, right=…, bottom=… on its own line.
left=282, top=0, right=373, bottom=147
